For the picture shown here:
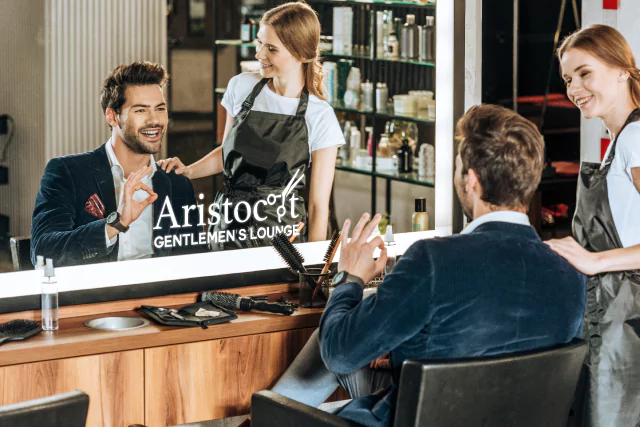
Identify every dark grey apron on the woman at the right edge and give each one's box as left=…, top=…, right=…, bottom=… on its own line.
left=573, top=109, right=640, bottom=427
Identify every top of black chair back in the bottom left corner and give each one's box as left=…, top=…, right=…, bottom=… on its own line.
left=0, top=390, right=89, bottom=427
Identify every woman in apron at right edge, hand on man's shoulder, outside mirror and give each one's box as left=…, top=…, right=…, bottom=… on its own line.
left=547, top=25, right=640, bottom=427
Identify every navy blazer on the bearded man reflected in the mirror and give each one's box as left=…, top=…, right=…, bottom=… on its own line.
left=31, top=145, right=205, bottom=267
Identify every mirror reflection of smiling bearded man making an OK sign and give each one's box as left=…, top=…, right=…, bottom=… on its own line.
left=31, top=62, right=199, bottom=266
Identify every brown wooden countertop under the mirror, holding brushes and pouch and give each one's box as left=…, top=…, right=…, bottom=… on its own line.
left=0, top=294, right=323, bottom=366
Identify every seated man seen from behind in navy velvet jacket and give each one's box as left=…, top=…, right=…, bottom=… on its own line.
left=264, top=105, right=586, bottom=426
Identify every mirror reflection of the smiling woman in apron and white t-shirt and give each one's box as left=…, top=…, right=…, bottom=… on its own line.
left=160, top=3, right=344, bottom=249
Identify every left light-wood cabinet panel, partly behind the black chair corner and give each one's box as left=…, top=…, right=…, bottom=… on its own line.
left=0, top=350, right=144, bottom=427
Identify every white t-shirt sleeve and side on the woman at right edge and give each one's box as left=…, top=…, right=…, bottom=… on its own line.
left=603, top=122, right=640, bottom=248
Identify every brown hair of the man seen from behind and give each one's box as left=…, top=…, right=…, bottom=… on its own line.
left=456, top=104, right=544, bottom=208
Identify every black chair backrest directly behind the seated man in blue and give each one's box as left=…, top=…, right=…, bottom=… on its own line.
left=393, top=340, right=587, bottom=427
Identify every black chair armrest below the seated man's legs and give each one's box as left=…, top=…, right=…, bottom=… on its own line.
left=251, top=390, right=352, bottom=427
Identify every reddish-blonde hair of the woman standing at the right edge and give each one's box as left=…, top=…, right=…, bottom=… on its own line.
left=557, top=24, right=640, bottom=106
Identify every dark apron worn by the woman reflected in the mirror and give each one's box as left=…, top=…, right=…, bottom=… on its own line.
left=209, top=79, right=309, bottom=251
